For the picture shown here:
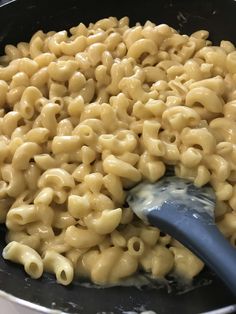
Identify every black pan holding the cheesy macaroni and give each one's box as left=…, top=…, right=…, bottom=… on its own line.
left=0, top=0, right=236, bottom=314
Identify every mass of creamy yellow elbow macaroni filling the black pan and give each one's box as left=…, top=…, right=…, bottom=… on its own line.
left=0, top=17, right=236, bottom=285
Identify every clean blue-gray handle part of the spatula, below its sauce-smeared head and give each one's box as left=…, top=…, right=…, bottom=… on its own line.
left=147, top=203, right=236, bottom=295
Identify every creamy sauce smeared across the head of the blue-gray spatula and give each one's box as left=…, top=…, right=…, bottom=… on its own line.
left=127, top=176, right=215, bottom=222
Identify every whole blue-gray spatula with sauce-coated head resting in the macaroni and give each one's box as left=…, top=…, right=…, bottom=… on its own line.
left=127, top=173, right=236, bottom=295
